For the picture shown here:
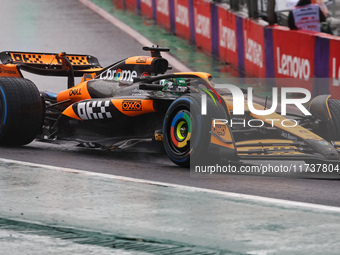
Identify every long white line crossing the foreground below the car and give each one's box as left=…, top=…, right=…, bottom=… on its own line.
left=0, top=158, right=340, bottom=213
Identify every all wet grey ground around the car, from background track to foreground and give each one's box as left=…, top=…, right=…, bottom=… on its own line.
left=0, top=0, right=340, bottom=255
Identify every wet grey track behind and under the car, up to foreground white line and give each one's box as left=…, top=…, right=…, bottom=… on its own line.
left=0, top=0, right=340, bottom=209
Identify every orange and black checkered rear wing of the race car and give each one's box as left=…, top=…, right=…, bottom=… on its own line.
left=0, top=51, right=102, bottom=77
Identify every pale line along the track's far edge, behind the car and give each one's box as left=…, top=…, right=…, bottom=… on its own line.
left=79, top=0, right=192, bottom=72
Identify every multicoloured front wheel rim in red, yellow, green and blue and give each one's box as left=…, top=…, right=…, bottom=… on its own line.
left=170, top=110, right=192, bottom=154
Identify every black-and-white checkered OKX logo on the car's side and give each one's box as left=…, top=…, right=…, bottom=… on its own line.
left=77, top=100, right=112, bottom=120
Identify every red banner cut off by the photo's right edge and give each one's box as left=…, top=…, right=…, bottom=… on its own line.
left=329, top=37, right=340, bottom=99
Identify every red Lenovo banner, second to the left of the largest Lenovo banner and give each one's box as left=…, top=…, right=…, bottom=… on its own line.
left=218, top=6, right=238, bottom=66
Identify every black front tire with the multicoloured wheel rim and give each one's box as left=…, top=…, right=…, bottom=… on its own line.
left=163, top=93, right=227, bottom=167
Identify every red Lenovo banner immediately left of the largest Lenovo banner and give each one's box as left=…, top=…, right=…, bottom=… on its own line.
left=243, top=19, right=266, bottom=78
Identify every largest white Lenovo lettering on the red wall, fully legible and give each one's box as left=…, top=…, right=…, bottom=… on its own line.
left=276, top=47, right=311, bottom=81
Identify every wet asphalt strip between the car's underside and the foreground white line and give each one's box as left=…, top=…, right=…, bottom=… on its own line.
left=0, top=142, right=340, bottom=206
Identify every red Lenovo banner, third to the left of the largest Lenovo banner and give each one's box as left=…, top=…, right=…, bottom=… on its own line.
left=194, top=0, right=211, bottom=52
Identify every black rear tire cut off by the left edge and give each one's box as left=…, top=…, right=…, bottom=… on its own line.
left=0, top=77, right=43, bottom=146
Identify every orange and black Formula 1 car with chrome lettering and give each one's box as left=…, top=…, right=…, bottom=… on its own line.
left=0, top=46, right=340, bottom=166
